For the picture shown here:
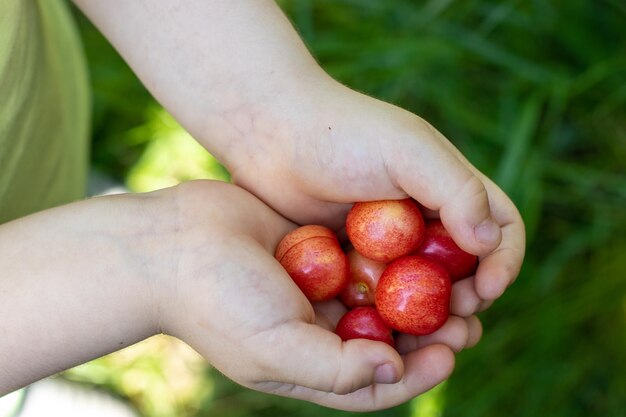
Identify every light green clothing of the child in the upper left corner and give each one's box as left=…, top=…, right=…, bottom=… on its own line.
left=0, top=0, right=90, bottom=224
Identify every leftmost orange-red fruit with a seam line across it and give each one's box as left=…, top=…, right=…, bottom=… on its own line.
left=275, top=225, right=350, bottom=301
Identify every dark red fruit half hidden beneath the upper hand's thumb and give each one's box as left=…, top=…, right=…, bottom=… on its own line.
left=415, top=220, right=478, bottom=282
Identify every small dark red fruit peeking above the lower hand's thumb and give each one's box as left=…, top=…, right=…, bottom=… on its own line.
left=335, top=307, right=395, bottom=347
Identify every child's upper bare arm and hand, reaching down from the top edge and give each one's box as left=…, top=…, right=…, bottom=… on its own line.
left=75, top=0, right=525, bottom=315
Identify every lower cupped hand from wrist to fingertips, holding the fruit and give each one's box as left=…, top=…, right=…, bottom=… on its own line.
left=158, top=181, right=480, bottom=410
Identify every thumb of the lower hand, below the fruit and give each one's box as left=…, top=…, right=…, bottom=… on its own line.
left=258, top=321, right=404, bottom=394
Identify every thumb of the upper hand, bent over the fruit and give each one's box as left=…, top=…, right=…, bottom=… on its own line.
left=386, top=121, right=502, bottom=255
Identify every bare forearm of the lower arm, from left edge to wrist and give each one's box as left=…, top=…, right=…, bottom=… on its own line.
left=0, top=190, right=169, bottom=395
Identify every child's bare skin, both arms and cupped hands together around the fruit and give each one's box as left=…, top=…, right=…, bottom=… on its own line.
left=0, top=0, right=524, bottom=410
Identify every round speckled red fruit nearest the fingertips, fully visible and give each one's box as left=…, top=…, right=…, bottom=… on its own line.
left=376, top=256, right=452, bottom=336
